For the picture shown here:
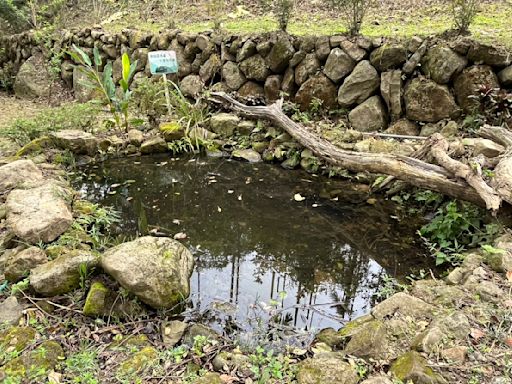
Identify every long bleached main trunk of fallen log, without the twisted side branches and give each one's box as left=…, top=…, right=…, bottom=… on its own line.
left=211, top=92, right=486, bottom=207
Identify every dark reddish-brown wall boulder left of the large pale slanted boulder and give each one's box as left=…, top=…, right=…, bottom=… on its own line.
left=295, top=74, right=336, bottom=110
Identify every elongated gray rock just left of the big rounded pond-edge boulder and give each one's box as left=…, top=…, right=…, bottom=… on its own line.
left=29, top=250, right=98, bottom=296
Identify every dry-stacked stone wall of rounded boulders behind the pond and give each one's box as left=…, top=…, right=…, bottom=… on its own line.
left=0, top=29, right=512, bottom=133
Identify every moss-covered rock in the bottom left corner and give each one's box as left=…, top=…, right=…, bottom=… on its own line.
left=0, top=340, right=64, bottom=382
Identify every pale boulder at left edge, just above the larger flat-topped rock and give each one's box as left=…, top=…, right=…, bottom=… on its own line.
left=0, top=160, right=43, bottom=193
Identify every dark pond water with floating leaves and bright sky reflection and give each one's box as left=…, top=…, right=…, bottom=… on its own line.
left=75, top=156, right=431, bottom=340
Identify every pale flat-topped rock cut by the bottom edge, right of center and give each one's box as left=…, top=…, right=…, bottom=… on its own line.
left=297, top=356, right=359, bottom=384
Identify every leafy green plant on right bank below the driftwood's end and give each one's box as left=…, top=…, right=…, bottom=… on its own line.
left=419, top=201, right=499, bottom=265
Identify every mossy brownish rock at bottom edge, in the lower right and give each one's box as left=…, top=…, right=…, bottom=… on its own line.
left=390, top=351, right=446, bottom=384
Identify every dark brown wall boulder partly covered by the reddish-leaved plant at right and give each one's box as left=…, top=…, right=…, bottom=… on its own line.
left=454, top=65, right=499, bottom=113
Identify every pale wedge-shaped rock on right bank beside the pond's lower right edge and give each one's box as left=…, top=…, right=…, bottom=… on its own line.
left=372, top=292, right=434, bottom=319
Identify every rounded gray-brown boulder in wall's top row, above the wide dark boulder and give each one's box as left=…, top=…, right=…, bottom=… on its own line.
left=421, top=45, right=468, bottom=84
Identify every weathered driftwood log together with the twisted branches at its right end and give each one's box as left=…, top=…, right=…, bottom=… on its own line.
left=211, top=92, right=512, bottom=212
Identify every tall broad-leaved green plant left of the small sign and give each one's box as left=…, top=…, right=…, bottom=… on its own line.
left=69, top=44, right=137, bottom=131
